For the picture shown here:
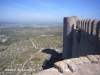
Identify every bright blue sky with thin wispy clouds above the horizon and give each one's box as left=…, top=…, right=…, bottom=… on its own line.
left=0, top=0, right=100, bottom=22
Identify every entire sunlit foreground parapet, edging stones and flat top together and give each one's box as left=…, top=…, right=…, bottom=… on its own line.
left=34, top=55, right=100, bottom=75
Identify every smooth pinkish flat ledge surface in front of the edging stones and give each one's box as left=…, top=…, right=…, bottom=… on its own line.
left=32, top=64, right=100, bottom=75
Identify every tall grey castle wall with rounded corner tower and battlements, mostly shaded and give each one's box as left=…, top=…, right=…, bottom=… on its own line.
left=62, top=16, right=100, bottom=59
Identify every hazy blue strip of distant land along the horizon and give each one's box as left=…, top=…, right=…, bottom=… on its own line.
left=0, top=22, right=63, bottom=28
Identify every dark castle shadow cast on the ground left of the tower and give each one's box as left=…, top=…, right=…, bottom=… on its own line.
left=42, top=49, right=62, bottom=70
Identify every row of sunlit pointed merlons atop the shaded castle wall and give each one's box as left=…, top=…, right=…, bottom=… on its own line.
left=79, top=19, right=100, bottom=37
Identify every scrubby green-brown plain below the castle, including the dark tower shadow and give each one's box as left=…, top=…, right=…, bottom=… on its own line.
left=0, top=26, right=62, bottom=75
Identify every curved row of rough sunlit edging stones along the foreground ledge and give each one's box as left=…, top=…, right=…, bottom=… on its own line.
left=54, top=55, right=100, bottom=73
